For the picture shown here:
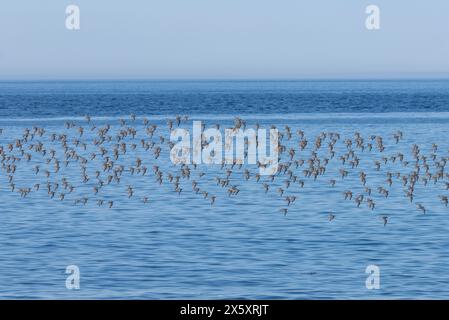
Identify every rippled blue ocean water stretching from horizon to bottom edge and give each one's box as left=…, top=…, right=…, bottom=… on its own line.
left=0, top=80, right=449, bottom=299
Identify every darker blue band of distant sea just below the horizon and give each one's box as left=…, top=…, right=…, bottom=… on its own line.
left=0, top=80, right=449, bottom=118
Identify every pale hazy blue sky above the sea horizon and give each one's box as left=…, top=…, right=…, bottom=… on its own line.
left=0, top=0, right=449, bottom=80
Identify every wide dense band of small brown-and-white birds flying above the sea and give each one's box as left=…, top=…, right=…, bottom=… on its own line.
left=0, top=114, right=449, bottom=226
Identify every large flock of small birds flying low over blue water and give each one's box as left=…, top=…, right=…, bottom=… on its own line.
left=0, top=115, right=449, bottom=226
